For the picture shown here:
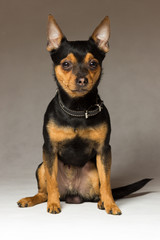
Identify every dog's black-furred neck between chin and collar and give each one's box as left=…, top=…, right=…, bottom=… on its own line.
left=58, top=86, right=100, bottom=111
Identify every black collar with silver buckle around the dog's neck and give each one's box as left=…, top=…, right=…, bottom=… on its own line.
left=58, top=92, right=103, bottom=119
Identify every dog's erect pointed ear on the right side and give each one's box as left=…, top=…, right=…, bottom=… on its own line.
left=92, top=17, right=110, bottom=53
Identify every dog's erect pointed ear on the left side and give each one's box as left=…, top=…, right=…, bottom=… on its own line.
left=47, top=15, right=64, bottom=52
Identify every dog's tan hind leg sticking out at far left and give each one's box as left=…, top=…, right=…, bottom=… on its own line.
left=17, top=163, right=48, bottom=207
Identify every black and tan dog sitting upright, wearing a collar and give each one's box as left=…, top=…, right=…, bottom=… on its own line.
left=18, top=15, right=150, bottom=215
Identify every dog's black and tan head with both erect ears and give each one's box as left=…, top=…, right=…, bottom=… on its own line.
left=47, top=15, right=110, bottom=97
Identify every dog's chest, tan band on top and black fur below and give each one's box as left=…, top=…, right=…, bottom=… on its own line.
left=47, top=120, right=107, bottom=166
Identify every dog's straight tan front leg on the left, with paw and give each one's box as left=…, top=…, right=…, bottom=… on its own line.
left=43, top=150, right=61, bottom=214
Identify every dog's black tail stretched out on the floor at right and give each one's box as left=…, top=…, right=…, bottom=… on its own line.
left=112, top=178, right=152, bottom=200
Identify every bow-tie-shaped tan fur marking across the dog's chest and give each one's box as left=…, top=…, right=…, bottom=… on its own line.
left=47, top=120, right=108, bottom=144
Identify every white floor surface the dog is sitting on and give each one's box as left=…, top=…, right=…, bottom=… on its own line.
left=0, top=176, right=160, bottom=240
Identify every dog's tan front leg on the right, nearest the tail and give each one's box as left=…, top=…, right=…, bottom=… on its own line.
left=96, top=146, right=121, bottom=215
